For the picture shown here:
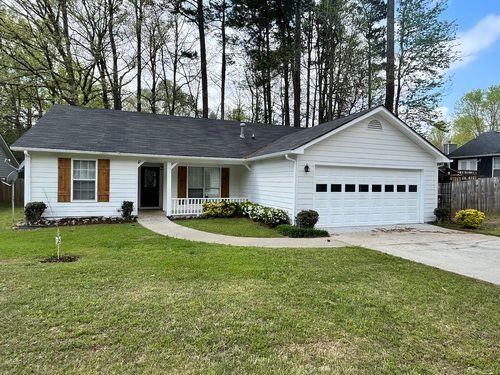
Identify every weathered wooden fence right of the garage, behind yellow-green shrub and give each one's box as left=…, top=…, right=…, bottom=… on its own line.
left=438, top=177, right=500, bottom=214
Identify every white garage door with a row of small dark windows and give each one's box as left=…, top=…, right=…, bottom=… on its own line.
left=314, top=166, right=421, bottom=227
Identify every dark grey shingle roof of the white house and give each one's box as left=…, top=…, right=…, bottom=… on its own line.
left=13, top=105, right=373, bottom=158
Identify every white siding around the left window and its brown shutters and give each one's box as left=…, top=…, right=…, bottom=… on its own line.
left=26, top=153, right=138, bottom=217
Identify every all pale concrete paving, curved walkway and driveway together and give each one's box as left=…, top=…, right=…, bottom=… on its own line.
left=139, top=212, right=500, bottom=285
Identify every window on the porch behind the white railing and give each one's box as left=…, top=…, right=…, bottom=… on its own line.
left=188, top=167, right=220, bottom=198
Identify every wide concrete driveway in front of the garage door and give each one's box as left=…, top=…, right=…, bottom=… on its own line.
left=330, top=224, right=500, bottom=285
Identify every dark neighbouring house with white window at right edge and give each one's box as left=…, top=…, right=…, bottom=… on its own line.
left=448, top=131, right=500, bottom=178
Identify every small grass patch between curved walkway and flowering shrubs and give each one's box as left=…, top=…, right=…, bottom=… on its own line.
left=175, top=217, right=283, bottom=237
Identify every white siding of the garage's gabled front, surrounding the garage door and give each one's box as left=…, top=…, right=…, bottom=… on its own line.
left=297, top=116, right=438, bottom=221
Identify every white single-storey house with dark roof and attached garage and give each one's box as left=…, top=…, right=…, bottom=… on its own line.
left=12, top=105, right=449, bottom=227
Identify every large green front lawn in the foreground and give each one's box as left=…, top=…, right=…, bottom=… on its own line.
left=0, top=209, right=500, bottom=374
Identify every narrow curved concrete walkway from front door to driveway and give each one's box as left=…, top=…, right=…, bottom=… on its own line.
left=139, top=211, right=348, bottom=248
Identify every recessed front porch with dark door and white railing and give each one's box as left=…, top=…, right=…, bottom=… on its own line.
left=137, top=161, right=249, bottom=217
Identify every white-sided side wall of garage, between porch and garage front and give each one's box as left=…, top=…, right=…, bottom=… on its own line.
left=241, top=157, right=294, bottom=217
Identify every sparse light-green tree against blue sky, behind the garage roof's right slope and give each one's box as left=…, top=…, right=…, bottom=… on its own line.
left=394, top=0, right=458, bottom=131
